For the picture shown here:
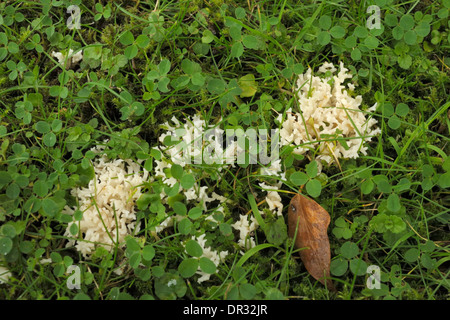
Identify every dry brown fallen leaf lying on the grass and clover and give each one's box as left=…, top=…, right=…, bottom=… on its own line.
left=288, top=194, right=335, bottom=291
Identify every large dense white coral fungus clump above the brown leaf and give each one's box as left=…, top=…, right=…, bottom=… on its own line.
left=279, top=62, right=381, bottom=168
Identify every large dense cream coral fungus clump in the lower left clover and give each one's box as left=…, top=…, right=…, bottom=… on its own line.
left=64, top=148, right=148, bottom=258
